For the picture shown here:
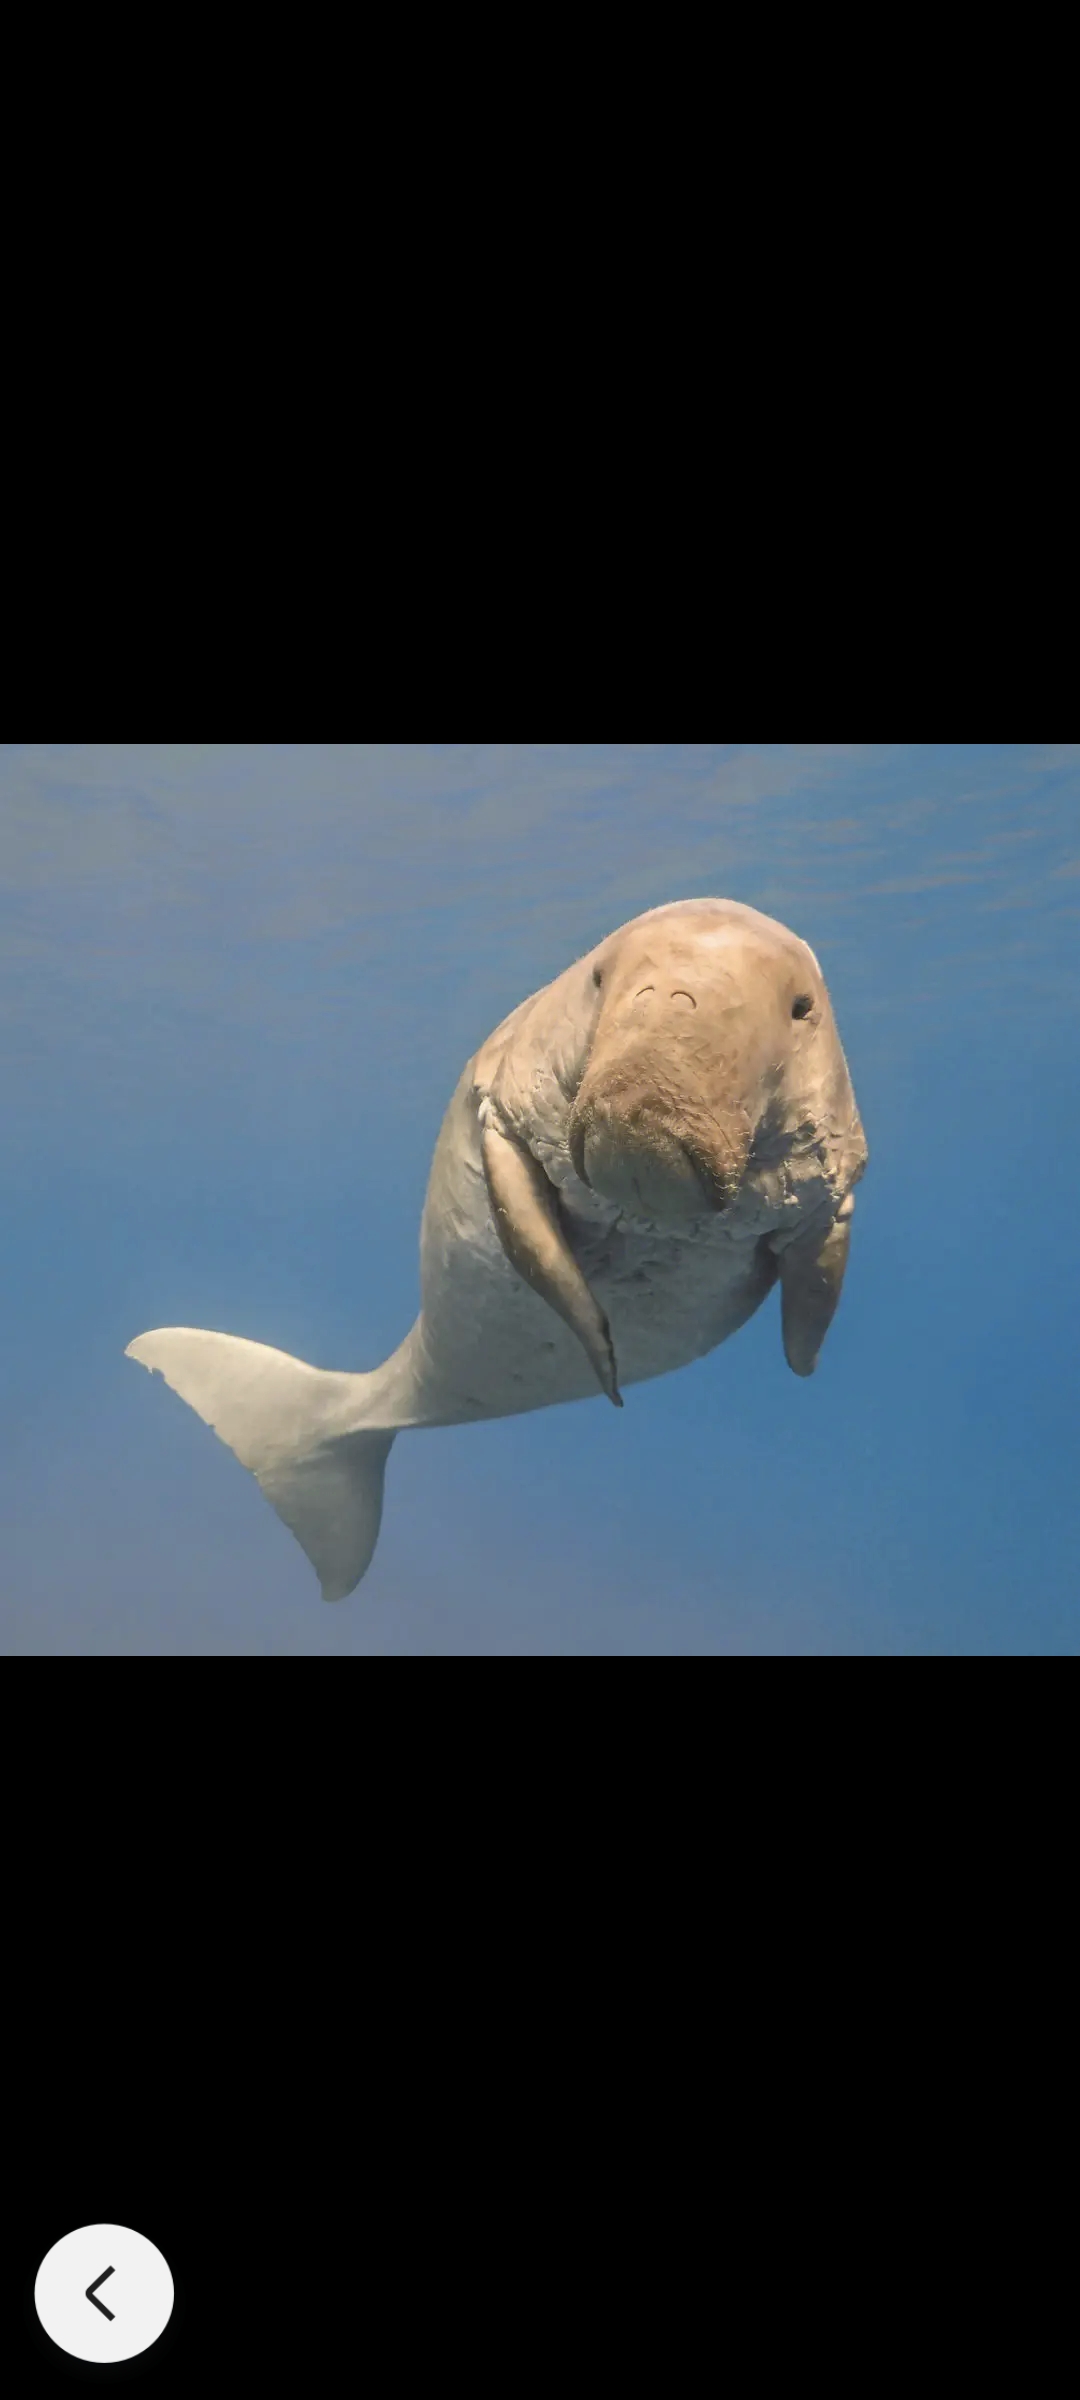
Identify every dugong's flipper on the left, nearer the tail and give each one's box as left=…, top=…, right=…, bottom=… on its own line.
left=482, top=1121, right=622, bottom=1409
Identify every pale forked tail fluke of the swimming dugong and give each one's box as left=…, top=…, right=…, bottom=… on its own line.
left=125, top=1325, right=394, bottom=1601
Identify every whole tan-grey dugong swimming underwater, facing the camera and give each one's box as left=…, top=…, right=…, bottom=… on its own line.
left=125, top=900, right=869, bottom=1601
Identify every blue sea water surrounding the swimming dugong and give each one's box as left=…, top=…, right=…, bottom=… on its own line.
left=0, top=744, right=1080, bottom=1656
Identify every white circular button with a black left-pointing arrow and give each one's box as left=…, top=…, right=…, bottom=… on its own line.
left=34, top=2225, right=173, bottom=2364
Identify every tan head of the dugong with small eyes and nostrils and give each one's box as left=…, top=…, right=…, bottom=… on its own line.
left=566, top=900, right=862, bottom=1224
